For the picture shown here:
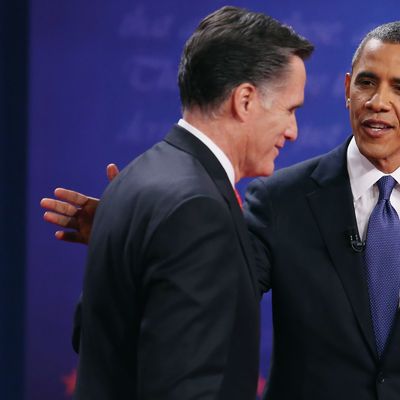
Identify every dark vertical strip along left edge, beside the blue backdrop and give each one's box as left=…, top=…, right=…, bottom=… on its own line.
left=0, top=0, right=28, bottom=400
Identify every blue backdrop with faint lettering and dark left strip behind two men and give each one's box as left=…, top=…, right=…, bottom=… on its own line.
left=0, top=0, right=399, bottom=400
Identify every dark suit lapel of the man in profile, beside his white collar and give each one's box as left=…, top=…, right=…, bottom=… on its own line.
left=164, top=125, right=258, bottom=300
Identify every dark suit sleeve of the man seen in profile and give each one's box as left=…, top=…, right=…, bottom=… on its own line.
left=138, top=197, right=244, bottom=400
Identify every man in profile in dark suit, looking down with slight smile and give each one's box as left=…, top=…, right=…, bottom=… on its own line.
left=40, top=7, right=312, bottom=400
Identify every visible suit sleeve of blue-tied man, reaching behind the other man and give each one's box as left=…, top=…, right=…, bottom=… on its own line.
left=244, top=179, right=274, bottom=294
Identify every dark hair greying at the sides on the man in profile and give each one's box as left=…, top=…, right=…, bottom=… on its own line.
left=178, top=6, right=314, bottom=110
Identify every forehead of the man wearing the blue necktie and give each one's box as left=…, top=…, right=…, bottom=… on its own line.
left=353, top=39, right=400, bottom=77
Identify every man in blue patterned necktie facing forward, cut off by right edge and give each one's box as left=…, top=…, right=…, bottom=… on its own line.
left=245, top=22, right=400, bottom=400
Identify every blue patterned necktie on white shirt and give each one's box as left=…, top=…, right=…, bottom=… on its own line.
left=365, top=175, right=400, bottom=356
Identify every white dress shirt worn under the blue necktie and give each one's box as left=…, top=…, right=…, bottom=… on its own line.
left=347, top=137, right=400, bottom=240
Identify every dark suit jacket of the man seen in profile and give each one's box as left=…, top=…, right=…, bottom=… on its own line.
left=76, top=126, right=259, bottom=400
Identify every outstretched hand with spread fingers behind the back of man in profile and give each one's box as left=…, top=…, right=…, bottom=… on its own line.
left=40, top=164, right=119, bottom=244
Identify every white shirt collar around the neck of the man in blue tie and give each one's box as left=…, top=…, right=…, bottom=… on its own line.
left=347, top=137, right=400, bottom=201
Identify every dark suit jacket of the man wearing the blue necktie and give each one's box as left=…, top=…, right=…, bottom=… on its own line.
left=246, top=138, right=400, bottom=400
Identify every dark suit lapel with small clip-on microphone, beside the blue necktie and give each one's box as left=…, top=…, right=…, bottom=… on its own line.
left=308, top=141, right=377, bottom=357
